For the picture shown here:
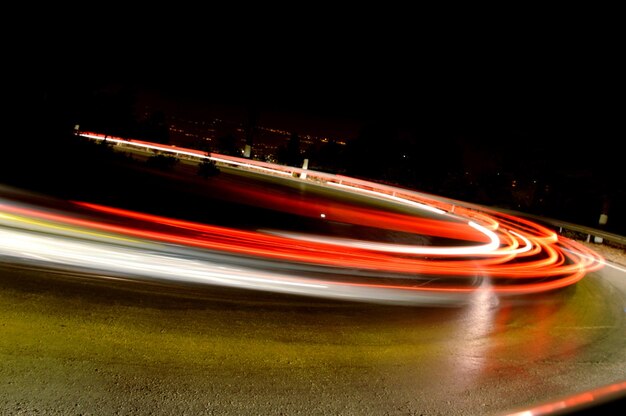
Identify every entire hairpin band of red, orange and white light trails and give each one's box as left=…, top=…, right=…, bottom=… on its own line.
left=0, top=133, right=603, bottom=304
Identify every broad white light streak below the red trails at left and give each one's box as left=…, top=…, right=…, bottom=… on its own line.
left=0, top=227, right=466, bottom=305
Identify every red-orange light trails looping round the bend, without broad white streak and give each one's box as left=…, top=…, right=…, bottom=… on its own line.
left=0, top=133, right=603, bottom=299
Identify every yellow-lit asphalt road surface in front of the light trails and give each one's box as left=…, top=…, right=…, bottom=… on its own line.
left=0, top=154, right=626, bottom=415
